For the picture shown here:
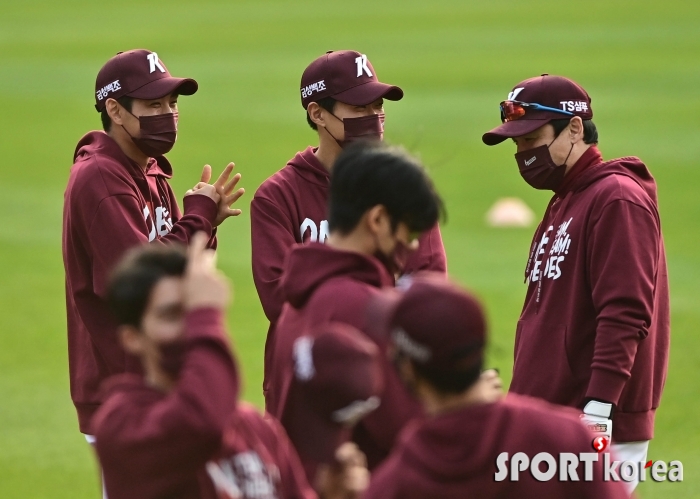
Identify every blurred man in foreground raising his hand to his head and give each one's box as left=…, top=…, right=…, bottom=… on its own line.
left=94, top=233, right=354, bottom=499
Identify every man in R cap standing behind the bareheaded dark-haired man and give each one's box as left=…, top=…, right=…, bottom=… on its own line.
left=250, top=50, right=446, bottom=356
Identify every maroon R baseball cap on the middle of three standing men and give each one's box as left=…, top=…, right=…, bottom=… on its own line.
left=301, top=50, right=403, bottom=109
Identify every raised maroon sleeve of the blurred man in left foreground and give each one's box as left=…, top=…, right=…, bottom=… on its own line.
left=96, top=308, right=238, bottom=479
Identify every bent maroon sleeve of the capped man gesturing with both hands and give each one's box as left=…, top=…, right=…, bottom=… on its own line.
left=87, top=194, right=216, bottom=299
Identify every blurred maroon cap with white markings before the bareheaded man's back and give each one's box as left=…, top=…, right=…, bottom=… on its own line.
left=281, top=323, right=384, bottom=463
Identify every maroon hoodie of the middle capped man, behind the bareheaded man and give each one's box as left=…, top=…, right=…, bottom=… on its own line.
left=250, top=147, right=447, bottom=330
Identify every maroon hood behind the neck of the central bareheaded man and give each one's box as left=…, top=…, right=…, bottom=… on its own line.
left=282, top=243, right=393, bottom=308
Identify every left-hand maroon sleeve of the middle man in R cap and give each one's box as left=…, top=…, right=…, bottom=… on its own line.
left=250, top=197, right=297, bottom=322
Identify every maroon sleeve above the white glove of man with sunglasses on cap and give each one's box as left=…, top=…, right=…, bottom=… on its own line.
left=586, top=200, right=661, bottom=404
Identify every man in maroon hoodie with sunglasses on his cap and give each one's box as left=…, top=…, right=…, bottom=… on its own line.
left=483, top=75, right=670, bottom=488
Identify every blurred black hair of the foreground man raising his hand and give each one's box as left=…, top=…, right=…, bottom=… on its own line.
left=107, top=244, right=187, bottom=328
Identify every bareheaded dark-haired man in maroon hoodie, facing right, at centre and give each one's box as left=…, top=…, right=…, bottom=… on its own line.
left=265, top=142, right=442, bottom=469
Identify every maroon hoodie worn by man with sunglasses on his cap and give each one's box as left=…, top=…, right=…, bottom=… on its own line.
left=510, top=147, right=670, bottom=442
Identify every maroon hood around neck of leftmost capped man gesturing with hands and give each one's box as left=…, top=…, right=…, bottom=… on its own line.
left=73, top=130, right=173, bottom=179
